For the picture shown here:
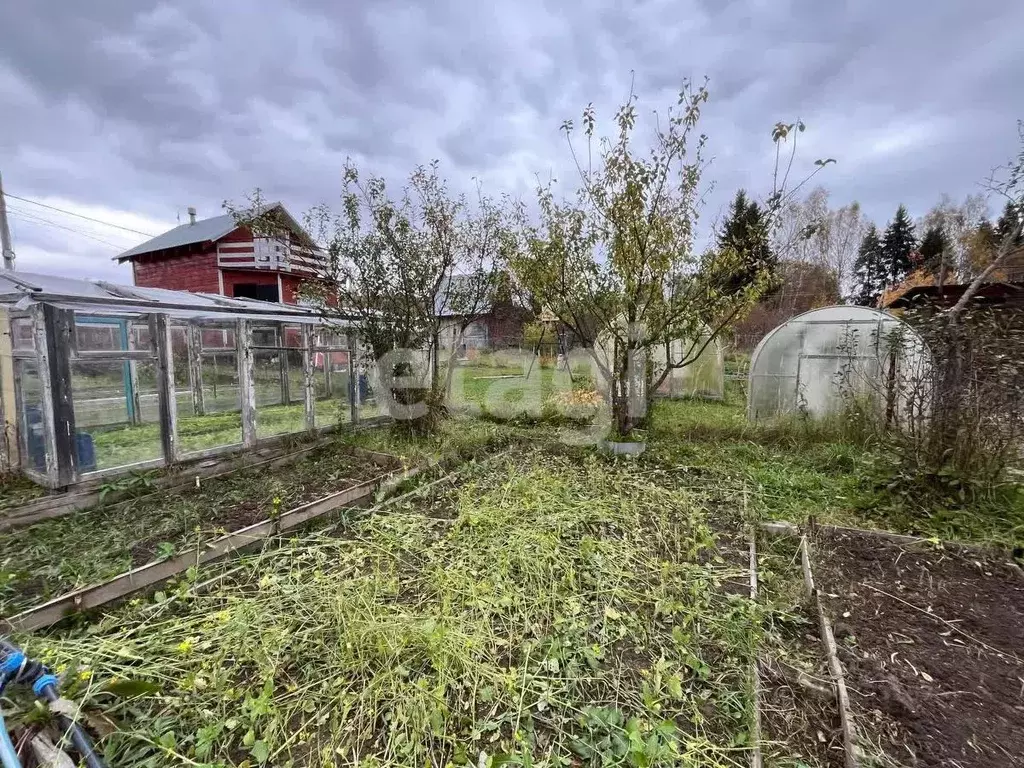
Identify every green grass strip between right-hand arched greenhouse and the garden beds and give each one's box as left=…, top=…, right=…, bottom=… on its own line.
left=647, top=385, right=1024, bottom=549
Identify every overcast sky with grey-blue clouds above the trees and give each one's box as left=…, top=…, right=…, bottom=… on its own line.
left=0, top=0, right=1024, bottom=282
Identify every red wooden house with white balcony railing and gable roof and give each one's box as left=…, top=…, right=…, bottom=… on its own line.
left=117, top=203, right=325, bottom=304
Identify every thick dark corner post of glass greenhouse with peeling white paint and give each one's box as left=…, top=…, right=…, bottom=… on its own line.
left=35, top=304, right=78, bottom=487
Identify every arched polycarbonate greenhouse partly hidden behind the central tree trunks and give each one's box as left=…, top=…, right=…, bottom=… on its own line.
left=594, top=327, right=725, bottom=399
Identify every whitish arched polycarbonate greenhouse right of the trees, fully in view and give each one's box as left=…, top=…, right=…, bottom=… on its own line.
left=746, top=305, right=931, bottom=419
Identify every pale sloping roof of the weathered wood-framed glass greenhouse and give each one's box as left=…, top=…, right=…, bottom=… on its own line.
left=0, top=270, right=352, bottom=323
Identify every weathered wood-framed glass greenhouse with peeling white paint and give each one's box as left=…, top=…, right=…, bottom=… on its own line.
left=0, top=271, right=374, bottom=487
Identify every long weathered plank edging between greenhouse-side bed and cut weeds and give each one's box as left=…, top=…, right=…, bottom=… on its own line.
left=0, top=466, right=395, bottom=632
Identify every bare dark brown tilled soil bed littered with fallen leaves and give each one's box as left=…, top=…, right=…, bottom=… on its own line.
left=814, top=534, right=1024, bottom=768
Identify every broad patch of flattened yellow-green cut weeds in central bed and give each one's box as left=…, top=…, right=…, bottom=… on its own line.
left=12, top=451, right=760, bottom=767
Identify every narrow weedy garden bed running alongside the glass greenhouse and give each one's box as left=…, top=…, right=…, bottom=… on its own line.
left=0, top=441, right=398, bottom=616
